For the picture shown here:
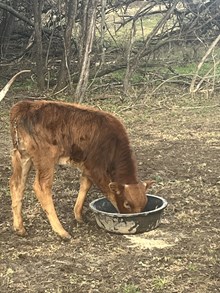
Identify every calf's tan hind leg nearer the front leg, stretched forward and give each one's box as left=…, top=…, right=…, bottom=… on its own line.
left=34, top=163, right=71, bottom=239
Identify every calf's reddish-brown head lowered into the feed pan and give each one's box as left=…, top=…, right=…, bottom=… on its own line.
left=109, top=181, right=154, bottom=214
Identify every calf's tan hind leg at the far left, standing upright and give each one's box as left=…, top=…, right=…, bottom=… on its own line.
left=10, top=149, right=32, bottom=236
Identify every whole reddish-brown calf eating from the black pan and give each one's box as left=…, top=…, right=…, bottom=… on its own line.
left=10, top=100, right=152, bottom=238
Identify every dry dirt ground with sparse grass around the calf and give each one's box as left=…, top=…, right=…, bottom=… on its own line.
left=0, top=90, right=220, bottom=293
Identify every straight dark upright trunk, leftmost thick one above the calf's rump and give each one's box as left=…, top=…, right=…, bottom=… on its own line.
left=33, top=0, right=45, bottom=91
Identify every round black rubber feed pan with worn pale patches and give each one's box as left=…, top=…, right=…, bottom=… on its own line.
left=90, top=194, right=167, bottom=234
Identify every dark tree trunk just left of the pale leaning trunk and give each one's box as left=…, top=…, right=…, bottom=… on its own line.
left=56, top=0, right=77, bottom=90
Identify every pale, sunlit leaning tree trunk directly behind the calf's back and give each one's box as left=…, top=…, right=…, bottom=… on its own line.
left=75, top=0, right=97, bottom=102
